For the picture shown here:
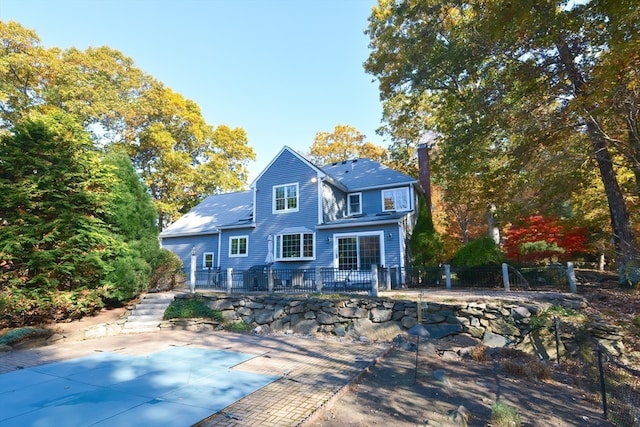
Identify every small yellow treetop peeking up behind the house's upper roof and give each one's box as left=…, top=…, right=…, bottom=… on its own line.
left=310, top=125, right=387, bottom=165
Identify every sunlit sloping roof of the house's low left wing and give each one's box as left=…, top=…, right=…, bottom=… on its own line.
left=160, top=190, right=253, bottom=237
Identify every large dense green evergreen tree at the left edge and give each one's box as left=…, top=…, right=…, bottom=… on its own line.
left=0, top=112, right=128, bottom=317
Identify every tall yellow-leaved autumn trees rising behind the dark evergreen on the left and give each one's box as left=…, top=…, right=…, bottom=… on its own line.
left=0, top=22, right=255, bottom=229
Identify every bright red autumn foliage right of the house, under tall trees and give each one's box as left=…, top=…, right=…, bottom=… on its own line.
left=503, top=215, right=587, bottom=264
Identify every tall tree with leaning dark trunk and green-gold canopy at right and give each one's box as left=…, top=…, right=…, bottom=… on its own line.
left=365, top=0, right=640, bottom=282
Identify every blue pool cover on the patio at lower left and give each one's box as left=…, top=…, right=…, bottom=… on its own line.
left=0, top=347, right=279, bottom=427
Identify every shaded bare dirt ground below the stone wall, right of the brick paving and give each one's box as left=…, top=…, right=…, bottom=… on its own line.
left=313, top=339, right=612, bottom=427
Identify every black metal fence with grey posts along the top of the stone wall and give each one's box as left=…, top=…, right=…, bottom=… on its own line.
left=188, top=264, right=580, bottom=293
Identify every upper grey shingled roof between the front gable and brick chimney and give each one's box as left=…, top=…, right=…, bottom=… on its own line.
left=322, top=158, right=417, bottom=191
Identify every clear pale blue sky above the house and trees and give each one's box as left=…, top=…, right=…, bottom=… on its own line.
left=0, top=0, right=387, bottom=182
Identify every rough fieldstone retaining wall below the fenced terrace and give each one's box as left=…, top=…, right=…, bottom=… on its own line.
left=166, top=294, right=624, bottom=359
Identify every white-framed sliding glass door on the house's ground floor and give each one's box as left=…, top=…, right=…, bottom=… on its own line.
left=337, top=234, right=382, bottom=270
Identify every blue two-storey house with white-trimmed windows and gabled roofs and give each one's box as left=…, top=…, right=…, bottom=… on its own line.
left=160, top=147, right=420, bottom=285
